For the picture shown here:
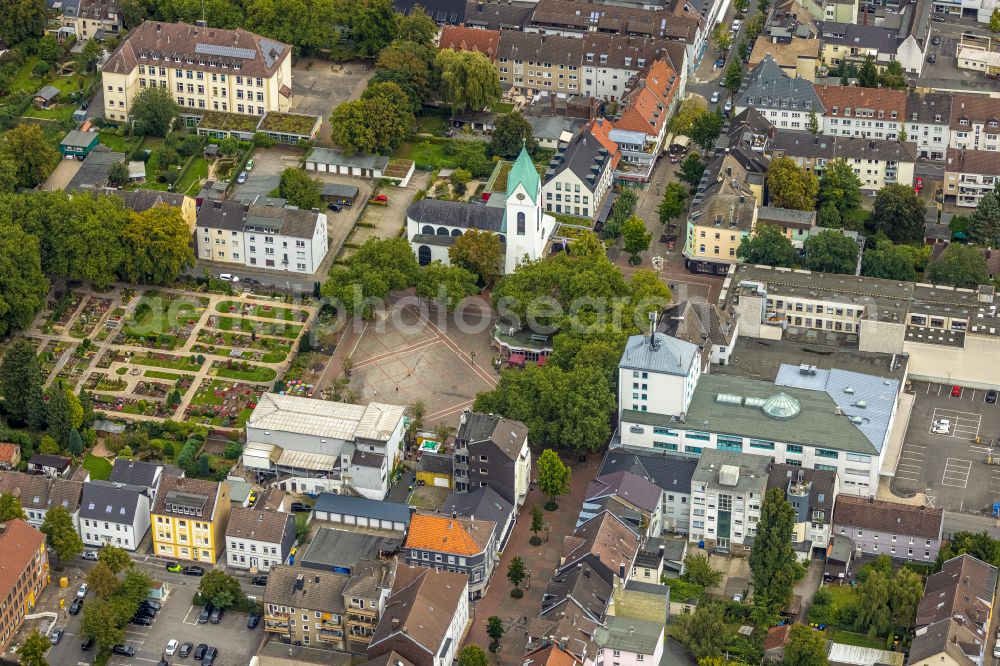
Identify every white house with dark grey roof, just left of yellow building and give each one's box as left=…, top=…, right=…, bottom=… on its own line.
left=79, top=480, right=150, bottom=551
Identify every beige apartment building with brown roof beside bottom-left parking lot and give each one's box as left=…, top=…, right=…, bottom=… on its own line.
left=264, top=565, right=348, bottom=652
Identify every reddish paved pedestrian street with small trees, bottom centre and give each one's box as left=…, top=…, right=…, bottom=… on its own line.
left=464, top=451, right=601, bottom=664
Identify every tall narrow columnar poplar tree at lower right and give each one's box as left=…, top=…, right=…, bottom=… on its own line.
left=750, top=488, right=802, bottom=617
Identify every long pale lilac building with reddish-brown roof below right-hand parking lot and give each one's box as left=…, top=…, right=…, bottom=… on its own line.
left=833, top=495, right=944, bottom=562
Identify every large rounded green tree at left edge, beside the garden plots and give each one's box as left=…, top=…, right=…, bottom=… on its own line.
left=0, top=222, right=49, bottom=338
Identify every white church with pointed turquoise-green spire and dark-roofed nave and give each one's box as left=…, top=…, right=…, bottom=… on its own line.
left=406, top=149, right=557, bottom=273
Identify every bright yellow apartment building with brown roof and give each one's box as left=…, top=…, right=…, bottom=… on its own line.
left=150, top=476, right=231, bottom=566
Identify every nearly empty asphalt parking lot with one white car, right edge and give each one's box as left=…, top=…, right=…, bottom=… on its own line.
left=890, top=381, right=1000, bottom=513
